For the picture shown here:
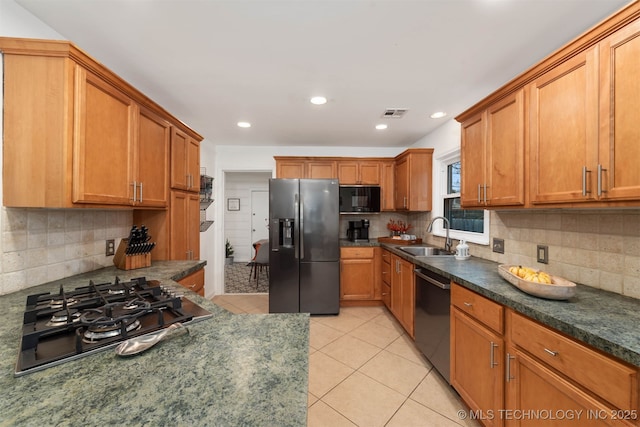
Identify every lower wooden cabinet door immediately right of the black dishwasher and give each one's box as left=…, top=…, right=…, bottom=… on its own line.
left=451, top=306, right=504, bottom=427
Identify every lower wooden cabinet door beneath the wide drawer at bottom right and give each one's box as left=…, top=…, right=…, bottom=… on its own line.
left=506, top=348, right=624, bottom=427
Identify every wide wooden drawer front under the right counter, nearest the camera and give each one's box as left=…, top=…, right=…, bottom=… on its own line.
left=508, top=311, right=638, bottom=410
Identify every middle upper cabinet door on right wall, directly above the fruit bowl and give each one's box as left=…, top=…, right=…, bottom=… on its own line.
left=529, top=48, right=598, bottom=204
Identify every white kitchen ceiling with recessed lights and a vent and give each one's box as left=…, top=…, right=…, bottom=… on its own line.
left=16, top=0, right=629, bottom=147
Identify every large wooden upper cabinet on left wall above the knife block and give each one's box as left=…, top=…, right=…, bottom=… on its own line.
left=0, top=37, right=199, bottom=208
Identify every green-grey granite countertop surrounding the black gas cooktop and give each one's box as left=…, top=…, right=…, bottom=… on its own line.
left=0, top=261, right=309, bottom=426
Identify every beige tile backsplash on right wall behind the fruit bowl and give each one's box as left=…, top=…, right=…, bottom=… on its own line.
left=418, top=209, right=640, bottom=298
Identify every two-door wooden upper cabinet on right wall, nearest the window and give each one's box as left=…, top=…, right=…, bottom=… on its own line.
left=461, top=90, right=525, bottom=207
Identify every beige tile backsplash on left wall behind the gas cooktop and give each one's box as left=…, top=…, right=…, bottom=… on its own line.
left=0, top=208, right=133, bottom=295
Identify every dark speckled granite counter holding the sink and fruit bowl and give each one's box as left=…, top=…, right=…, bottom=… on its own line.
left=381, top=243, right=640, bottom=367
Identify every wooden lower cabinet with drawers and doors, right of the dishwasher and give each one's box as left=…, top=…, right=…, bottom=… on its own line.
left=451, top=283, right=640, bottom=427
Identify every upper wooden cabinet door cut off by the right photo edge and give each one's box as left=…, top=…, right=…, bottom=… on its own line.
left=595, top=20, right=640, bottom=200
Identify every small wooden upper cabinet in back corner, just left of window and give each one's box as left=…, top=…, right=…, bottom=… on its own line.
left=395, top=148, right=433, bottom=212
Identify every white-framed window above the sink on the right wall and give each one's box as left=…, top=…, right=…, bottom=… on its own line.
left=431, top=150, right=489, bottom=245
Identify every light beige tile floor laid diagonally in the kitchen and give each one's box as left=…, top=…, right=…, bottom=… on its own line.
left=213, top=295, right=479, bottom=427
